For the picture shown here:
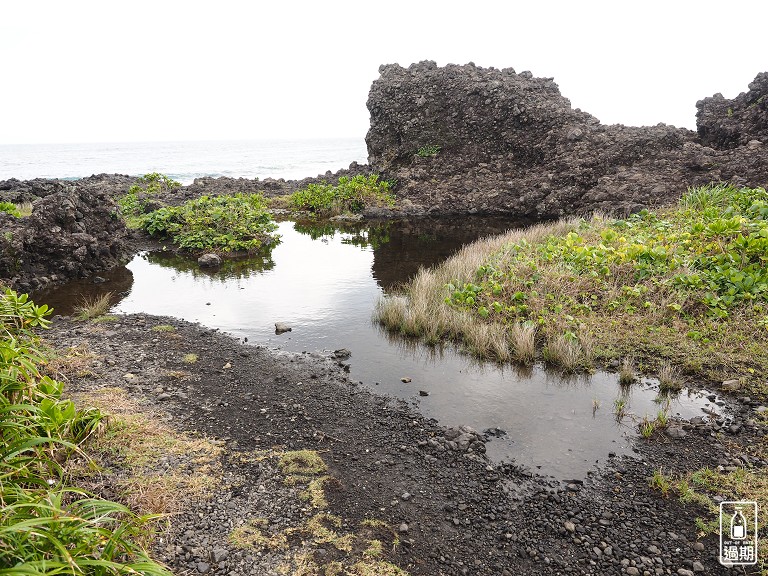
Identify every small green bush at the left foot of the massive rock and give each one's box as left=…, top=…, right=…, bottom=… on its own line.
left=288, top=174, right=394, bottom=216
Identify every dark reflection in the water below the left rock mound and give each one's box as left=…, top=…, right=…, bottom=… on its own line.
left=31, top=266, right=133, bottom=316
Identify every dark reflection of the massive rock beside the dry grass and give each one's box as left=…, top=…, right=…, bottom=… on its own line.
left=373, top=217, right=530, bottom=290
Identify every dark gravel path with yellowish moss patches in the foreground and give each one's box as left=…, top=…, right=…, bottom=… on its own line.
left=45, top=315, right=765, bottom=576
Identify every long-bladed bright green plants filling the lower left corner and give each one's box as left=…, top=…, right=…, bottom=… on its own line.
left=0, top=290, right=168, bottom=576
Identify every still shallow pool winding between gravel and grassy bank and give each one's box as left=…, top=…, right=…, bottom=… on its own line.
left=37, top=218, right=719, bottom=480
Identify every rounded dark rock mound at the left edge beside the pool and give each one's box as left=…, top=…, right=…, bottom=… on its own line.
left=0, top=182, right=130, bottom=291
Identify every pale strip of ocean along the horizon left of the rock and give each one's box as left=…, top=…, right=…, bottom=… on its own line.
left=0, top=137, right=368, bottom=184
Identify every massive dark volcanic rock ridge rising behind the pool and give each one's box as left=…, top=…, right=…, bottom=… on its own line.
left=366, top=62, right=768, bottom=218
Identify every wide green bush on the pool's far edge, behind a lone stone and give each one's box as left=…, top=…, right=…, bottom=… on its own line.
left=142, top=194, right=278, bottom=252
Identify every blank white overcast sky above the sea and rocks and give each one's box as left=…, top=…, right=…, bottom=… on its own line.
left=0, top=0, right=768, bottom=144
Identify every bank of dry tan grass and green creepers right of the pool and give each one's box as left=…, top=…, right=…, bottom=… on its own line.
left=376, top=185, right=768, bottom=394
